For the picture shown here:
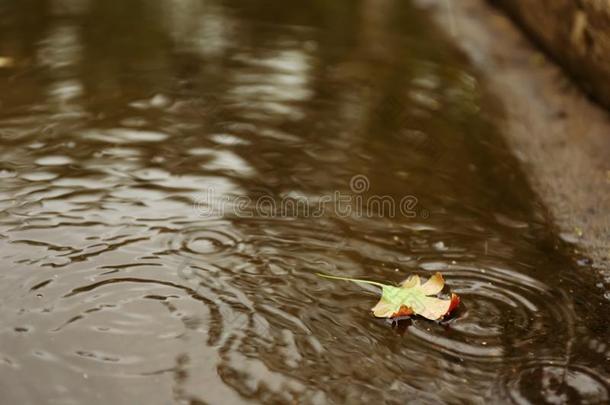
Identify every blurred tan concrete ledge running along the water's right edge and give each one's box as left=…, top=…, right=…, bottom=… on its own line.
left=414, top=0, right=610, bottom=278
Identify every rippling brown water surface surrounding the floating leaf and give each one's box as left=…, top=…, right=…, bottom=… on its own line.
left=0, top=0, right=610, bottom=404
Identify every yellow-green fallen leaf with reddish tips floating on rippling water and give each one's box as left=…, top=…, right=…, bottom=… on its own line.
left=317, top=273, right=460, bottom=321
